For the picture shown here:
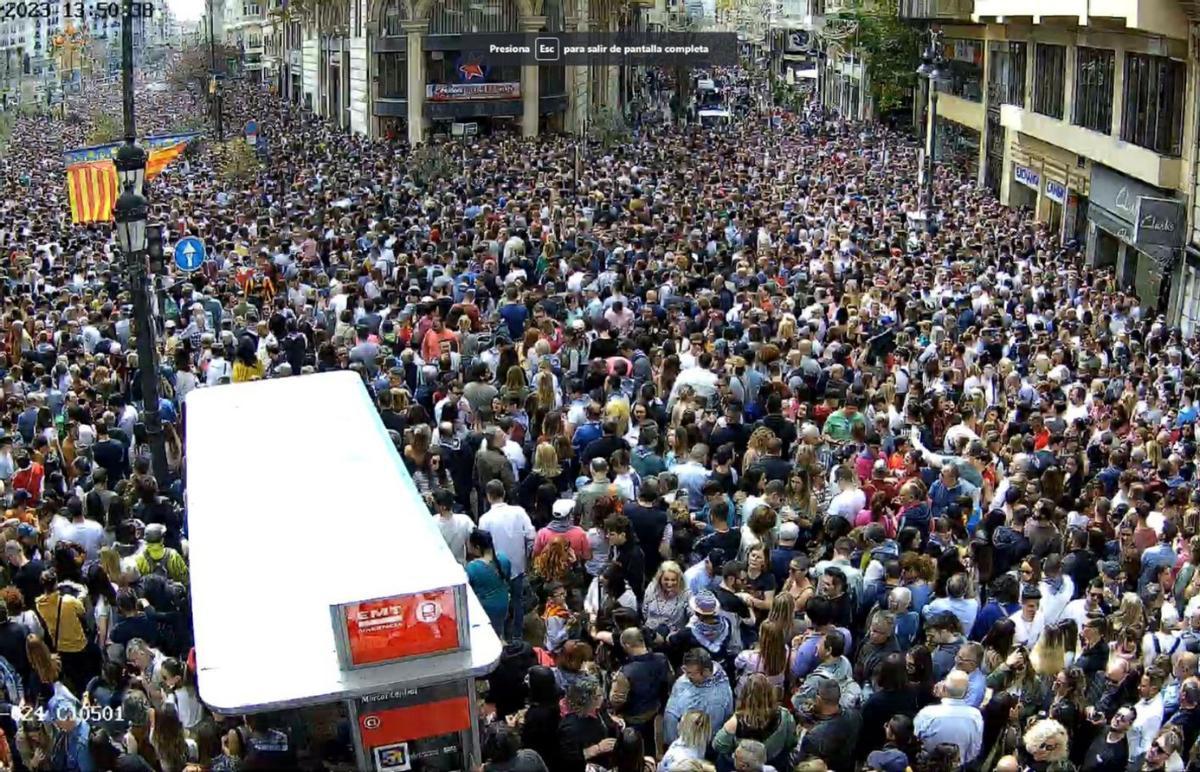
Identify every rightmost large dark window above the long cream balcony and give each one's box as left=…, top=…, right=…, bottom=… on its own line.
left=1121, top=54, right=1187, bottom=156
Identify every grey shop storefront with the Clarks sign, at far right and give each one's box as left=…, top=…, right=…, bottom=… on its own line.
left=1087, top=164, right=1187, bottom=311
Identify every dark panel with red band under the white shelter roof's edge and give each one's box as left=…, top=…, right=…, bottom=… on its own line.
left=355, top=681, right=472, bottom=772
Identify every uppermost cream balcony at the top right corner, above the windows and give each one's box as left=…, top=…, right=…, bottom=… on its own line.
left=971, top=0, right=1188, bottom=38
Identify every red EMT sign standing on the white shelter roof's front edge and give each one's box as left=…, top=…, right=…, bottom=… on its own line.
left=341, top=587, right=464, bottom=668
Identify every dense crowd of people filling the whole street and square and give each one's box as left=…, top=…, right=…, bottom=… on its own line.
left=0, top=58, right=1200, bottom=772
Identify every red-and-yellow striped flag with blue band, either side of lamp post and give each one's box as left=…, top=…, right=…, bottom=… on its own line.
left=64, top=132, right=199, bottom=225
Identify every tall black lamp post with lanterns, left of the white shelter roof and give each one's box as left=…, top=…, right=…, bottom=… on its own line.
left=113, top=0, right=168, bottom=485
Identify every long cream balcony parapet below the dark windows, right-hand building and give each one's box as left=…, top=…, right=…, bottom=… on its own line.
left=993, top=104, right=1184, bottom=190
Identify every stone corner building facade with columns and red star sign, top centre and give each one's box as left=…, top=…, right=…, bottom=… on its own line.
left=262, top=0, right=638, bottom=142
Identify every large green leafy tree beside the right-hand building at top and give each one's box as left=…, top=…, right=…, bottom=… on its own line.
left=841, top=0, right=920, bottom=113
